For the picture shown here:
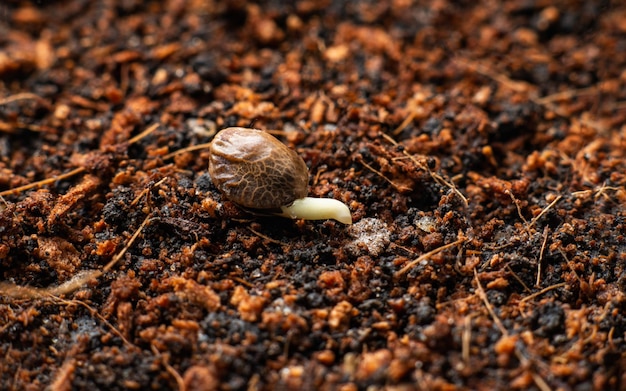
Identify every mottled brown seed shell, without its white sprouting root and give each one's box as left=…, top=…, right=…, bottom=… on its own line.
left=209, top=128, right=309, bottom=209
